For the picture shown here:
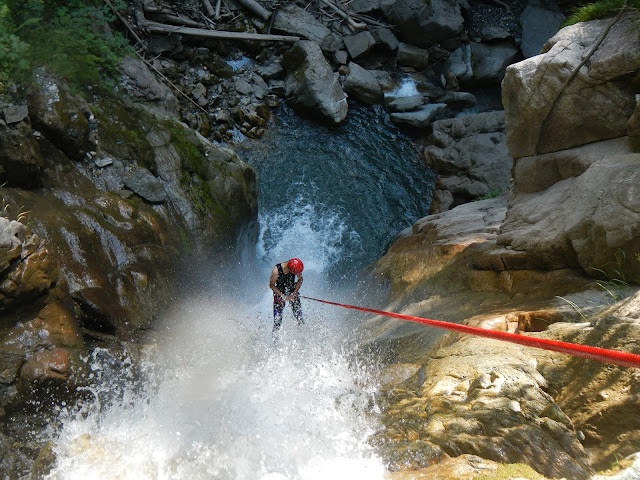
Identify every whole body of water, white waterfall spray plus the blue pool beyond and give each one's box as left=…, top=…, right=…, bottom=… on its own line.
left=49, top=103, right=432, bottom=480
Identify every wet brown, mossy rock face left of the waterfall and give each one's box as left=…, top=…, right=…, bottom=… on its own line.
left=0, top=68, right=257, bottom=416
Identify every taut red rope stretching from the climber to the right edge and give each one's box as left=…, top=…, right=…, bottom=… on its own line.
left=301, top=295, right=640, bottom=368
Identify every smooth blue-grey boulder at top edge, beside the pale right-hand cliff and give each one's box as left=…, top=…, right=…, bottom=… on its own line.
left=520, top=1, right=565, bottom=58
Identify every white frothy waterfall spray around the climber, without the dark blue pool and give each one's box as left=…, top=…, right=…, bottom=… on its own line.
left=48, top=203, right=385, bottom=480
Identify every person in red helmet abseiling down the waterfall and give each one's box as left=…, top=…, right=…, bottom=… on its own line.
left=269, top=258, right=304, bottom=332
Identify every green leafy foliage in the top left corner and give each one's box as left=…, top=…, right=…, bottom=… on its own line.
left=0, top=0, right=130, bottom=90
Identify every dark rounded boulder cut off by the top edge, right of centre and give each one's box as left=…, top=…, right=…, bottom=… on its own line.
left=381, top=0, right=464, bottom=47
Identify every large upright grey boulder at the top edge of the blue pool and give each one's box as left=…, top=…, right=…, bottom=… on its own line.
left=282, top=40, right=348, bottom=124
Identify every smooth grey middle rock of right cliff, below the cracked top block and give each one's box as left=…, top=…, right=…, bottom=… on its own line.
left=498, top=139, right=640, bottom=282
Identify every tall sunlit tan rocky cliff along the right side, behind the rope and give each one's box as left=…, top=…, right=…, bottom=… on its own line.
left=369, top=8, right=640, bottom=479
